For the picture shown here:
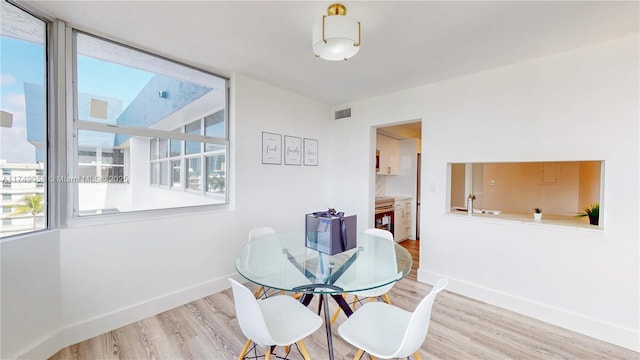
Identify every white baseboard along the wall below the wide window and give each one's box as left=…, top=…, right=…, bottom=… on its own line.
left=17, top=273, right=244, bottom=359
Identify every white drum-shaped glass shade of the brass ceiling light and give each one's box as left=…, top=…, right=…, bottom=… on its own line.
left=312, top=5, right=360, bottom=61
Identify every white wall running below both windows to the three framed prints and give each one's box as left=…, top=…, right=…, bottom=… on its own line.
left=1, top=75, right=333, bottom=359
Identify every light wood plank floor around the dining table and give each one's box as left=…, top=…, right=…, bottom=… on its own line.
left=51, top=241, right=640, bottom=360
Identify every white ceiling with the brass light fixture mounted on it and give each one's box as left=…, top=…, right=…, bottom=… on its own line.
left=28, top=1, right=640, bottom=106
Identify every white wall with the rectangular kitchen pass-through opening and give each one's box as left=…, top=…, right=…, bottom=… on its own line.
left=331, top=36, right=640, bottom=351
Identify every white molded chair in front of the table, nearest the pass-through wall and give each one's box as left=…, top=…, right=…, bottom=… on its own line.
left=338, top=279, right=448, bottom=359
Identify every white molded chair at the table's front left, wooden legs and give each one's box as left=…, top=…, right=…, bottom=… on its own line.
left=228, top=278, right=322, bottom=360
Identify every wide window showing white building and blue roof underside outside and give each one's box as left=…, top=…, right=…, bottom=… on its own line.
left=69, top=31, right=229, bottom=216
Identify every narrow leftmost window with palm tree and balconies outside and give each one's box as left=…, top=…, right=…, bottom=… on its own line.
left=0, top=1, right=47, bottom=237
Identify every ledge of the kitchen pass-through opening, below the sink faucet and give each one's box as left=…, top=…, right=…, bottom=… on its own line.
left=446, top=210, right=604, bottom=231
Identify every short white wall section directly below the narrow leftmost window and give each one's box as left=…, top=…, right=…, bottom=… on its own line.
left=0, top=231, right=62, bottom=359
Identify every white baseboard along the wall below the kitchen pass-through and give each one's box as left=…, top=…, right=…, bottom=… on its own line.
left=418, top=269, right=640, bottom=352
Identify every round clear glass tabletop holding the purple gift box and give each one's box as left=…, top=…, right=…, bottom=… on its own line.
left=235, top=231, right=412, bottom=294
